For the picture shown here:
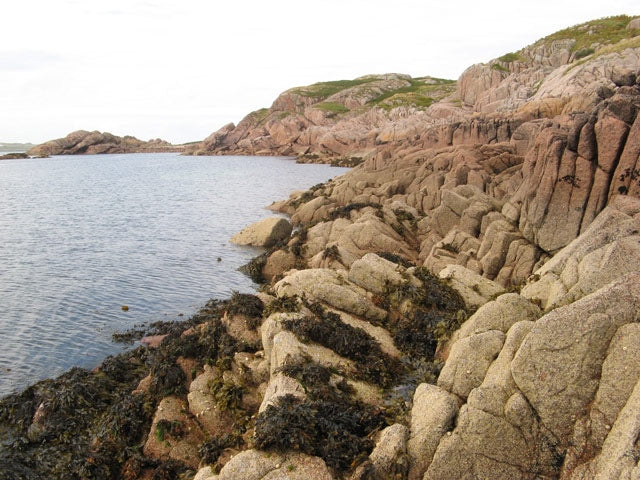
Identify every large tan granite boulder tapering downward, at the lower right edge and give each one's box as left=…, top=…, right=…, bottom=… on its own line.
left=511, top=273, right=640, bottom=445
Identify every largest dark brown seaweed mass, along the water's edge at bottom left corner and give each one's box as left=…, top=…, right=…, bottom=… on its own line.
left=0, top=301, right=237, bottom=480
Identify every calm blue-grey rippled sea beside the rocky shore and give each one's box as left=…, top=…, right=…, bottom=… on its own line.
left=0, top=154, right=347, bottom=396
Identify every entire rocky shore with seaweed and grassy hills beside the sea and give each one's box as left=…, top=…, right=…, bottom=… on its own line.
left=0, top=16, right=640, bottom=480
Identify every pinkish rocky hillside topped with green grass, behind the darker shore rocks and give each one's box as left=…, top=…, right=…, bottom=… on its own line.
left=187, top=16, right=640, bottom=164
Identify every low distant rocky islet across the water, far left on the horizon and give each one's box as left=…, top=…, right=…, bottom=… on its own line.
left=27, top=130, right=183, bottom=156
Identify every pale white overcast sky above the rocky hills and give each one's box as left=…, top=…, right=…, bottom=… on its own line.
left=0, top=0, right=640, bottom=143
